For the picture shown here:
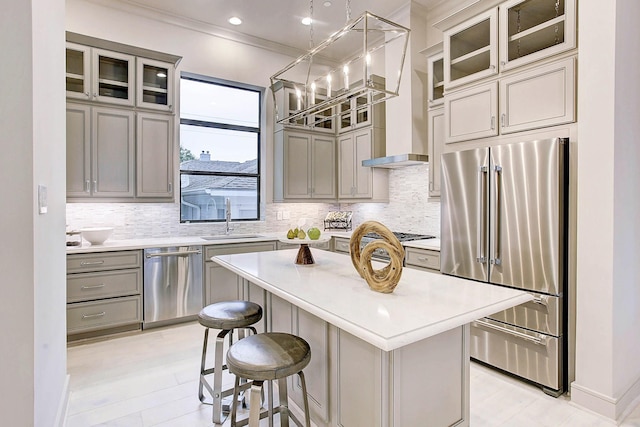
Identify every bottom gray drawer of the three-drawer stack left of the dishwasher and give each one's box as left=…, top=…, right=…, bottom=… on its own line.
left=67, top=296, right=142, bottom=334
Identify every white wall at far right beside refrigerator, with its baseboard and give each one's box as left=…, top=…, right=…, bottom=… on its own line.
left=571, top=0, right=640, bottom=419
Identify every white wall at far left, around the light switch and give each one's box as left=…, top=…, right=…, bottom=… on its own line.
left=0, top=0, right=67, bottom=426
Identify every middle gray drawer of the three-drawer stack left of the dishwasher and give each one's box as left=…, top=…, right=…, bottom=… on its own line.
left=67, top=269, right=142, bottom=302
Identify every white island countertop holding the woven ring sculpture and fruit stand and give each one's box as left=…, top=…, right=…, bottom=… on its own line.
left=212, top=249, right=533, bottom=351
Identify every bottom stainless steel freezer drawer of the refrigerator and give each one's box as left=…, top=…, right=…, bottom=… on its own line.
left=469, top=318, right=564, bottom=390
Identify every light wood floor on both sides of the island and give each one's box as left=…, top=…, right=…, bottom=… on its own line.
left=67, top=322, right=640, bottom=427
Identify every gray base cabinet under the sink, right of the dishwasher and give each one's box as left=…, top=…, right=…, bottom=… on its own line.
left=204, top=242, right=276, bottom=305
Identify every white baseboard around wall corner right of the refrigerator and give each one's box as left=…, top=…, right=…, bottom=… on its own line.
left=571, top=378, right=640, bottom=423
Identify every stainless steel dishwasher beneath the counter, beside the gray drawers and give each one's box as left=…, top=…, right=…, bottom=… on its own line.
left=142, top=246, right=204, bottom=329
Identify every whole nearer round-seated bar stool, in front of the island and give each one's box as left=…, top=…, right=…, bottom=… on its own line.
left=227, top=332, right=311, bottom=427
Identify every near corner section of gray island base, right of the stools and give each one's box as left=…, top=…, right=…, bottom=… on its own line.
left=331, top=325, right=469, bottom=427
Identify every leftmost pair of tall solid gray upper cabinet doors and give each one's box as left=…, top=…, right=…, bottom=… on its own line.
left=67, top=103, right=135, bottom=198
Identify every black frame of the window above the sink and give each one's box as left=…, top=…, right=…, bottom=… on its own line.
left=178, top=71, right=265, bottom=224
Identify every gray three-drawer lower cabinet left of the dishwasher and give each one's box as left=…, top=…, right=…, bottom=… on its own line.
left=67, top=250, right=142, bottom=340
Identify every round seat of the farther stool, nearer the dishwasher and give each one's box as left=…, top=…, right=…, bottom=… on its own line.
left=198, top=301, right=262, bottom=330
